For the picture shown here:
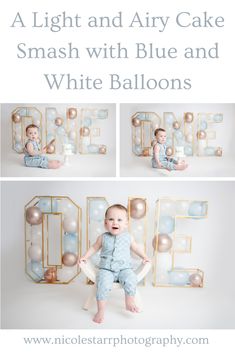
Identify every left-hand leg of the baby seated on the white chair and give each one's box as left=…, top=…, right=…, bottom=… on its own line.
left=93, top=269, right=114, bottom=324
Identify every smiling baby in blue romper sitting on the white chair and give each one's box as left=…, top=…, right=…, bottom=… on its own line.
left=79, top=204, right=149, bottom=323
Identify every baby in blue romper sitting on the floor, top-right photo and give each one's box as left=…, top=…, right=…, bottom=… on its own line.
left=152, top=128, right=188, bottom=171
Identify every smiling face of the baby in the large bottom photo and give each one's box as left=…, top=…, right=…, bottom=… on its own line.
left=104, top=207, right=128, bottom=235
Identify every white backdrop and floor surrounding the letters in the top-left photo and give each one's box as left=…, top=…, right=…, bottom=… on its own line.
left=1, top=103, right=116, bottom=177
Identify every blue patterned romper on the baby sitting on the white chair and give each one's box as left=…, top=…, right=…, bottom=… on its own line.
left=96, top=232, right=137, bottom=300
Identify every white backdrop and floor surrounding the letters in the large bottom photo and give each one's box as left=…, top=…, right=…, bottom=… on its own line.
left=2, top=181, right=235, bottom=329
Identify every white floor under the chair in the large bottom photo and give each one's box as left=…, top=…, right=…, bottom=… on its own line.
left=2, top=274, right=235, bottom=329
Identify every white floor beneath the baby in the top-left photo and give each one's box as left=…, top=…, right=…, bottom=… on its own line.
left=1, top=152, right=116, bottom=178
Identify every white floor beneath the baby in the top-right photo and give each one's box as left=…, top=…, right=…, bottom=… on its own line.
left=120, top=155, right=235, bottom=177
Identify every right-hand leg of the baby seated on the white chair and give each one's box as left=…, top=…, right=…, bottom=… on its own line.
left=119, top=269, right=140, bottom=313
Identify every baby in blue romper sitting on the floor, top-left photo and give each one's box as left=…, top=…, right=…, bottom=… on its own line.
left=24, top=124, right=61, bottom=169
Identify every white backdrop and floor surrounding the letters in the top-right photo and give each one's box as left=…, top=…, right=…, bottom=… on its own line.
left=120, top=103, right=235, bottom=177
